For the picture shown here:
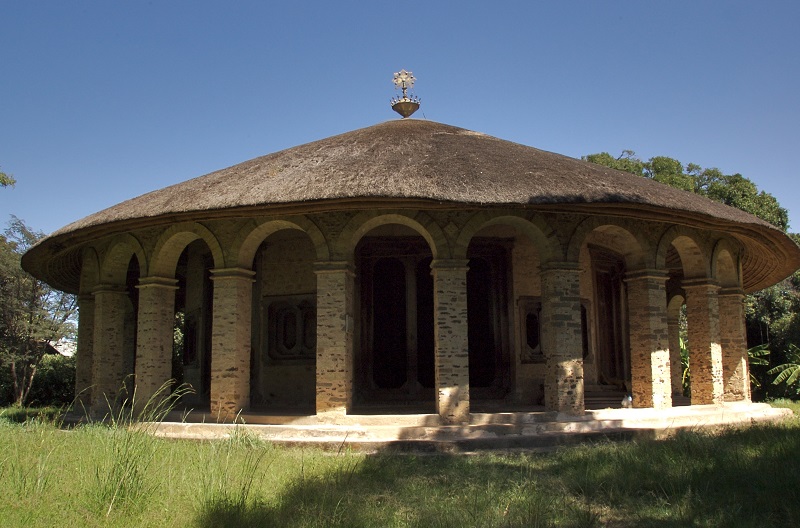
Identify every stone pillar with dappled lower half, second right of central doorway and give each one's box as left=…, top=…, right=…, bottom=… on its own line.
left=541, top=262, right=584, bottom=415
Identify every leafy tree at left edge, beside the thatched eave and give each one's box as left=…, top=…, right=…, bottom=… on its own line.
left=0, top=216, right=77, bottom=405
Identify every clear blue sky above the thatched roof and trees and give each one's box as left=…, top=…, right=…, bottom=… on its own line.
left=0, top=0, right=800, bottom=233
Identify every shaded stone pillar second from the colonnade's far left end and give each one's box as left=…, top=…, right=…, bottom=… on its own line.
left=92, top=284, right=130, bottom=416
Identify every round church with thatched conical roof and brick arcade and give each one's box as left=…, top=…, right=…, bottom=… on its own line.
left=23, top=119, right=800, bottom=424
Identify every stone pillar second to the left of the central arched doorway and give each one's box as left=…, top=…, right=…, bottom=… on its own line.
left=211, top=268, right=255, bottom=422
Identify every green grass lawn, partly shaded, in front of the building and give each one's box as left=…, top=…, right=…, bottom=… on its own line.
left=0, top=401, right=800, bottom=528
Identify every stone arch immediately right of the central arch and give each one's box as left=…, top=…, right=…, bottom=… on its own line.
left=453, top=211, right=561, bottom=262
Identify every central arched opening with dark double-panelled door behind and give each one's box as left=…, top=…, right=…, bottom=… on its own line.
left=354, top=224, right=435, bottom=412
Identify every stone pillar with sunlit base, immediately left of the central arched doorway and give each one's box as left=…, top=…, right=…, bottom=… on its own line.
left=314, top=262, right=355, bottom=422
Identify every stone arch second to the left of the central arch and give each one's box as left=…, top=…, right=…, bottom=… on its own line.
left=149, top=222, right=226, bottom=277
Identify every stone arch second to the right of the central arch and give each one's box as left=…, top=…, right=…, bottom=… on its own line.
left=566, top=217, right=652, bottom=269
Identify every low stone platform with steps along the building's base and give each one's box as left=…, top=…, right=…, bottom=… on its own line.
left=156, top=403, right=792, bottom=452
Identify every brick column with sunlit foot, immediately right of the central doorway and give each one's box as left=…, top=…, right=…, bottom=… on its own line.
left=431, top=260, right=469, bottom=424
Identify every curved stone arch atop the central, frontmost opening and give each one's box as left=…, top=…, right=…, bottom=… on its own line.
left=337, top=212, right=448, bottom=260
